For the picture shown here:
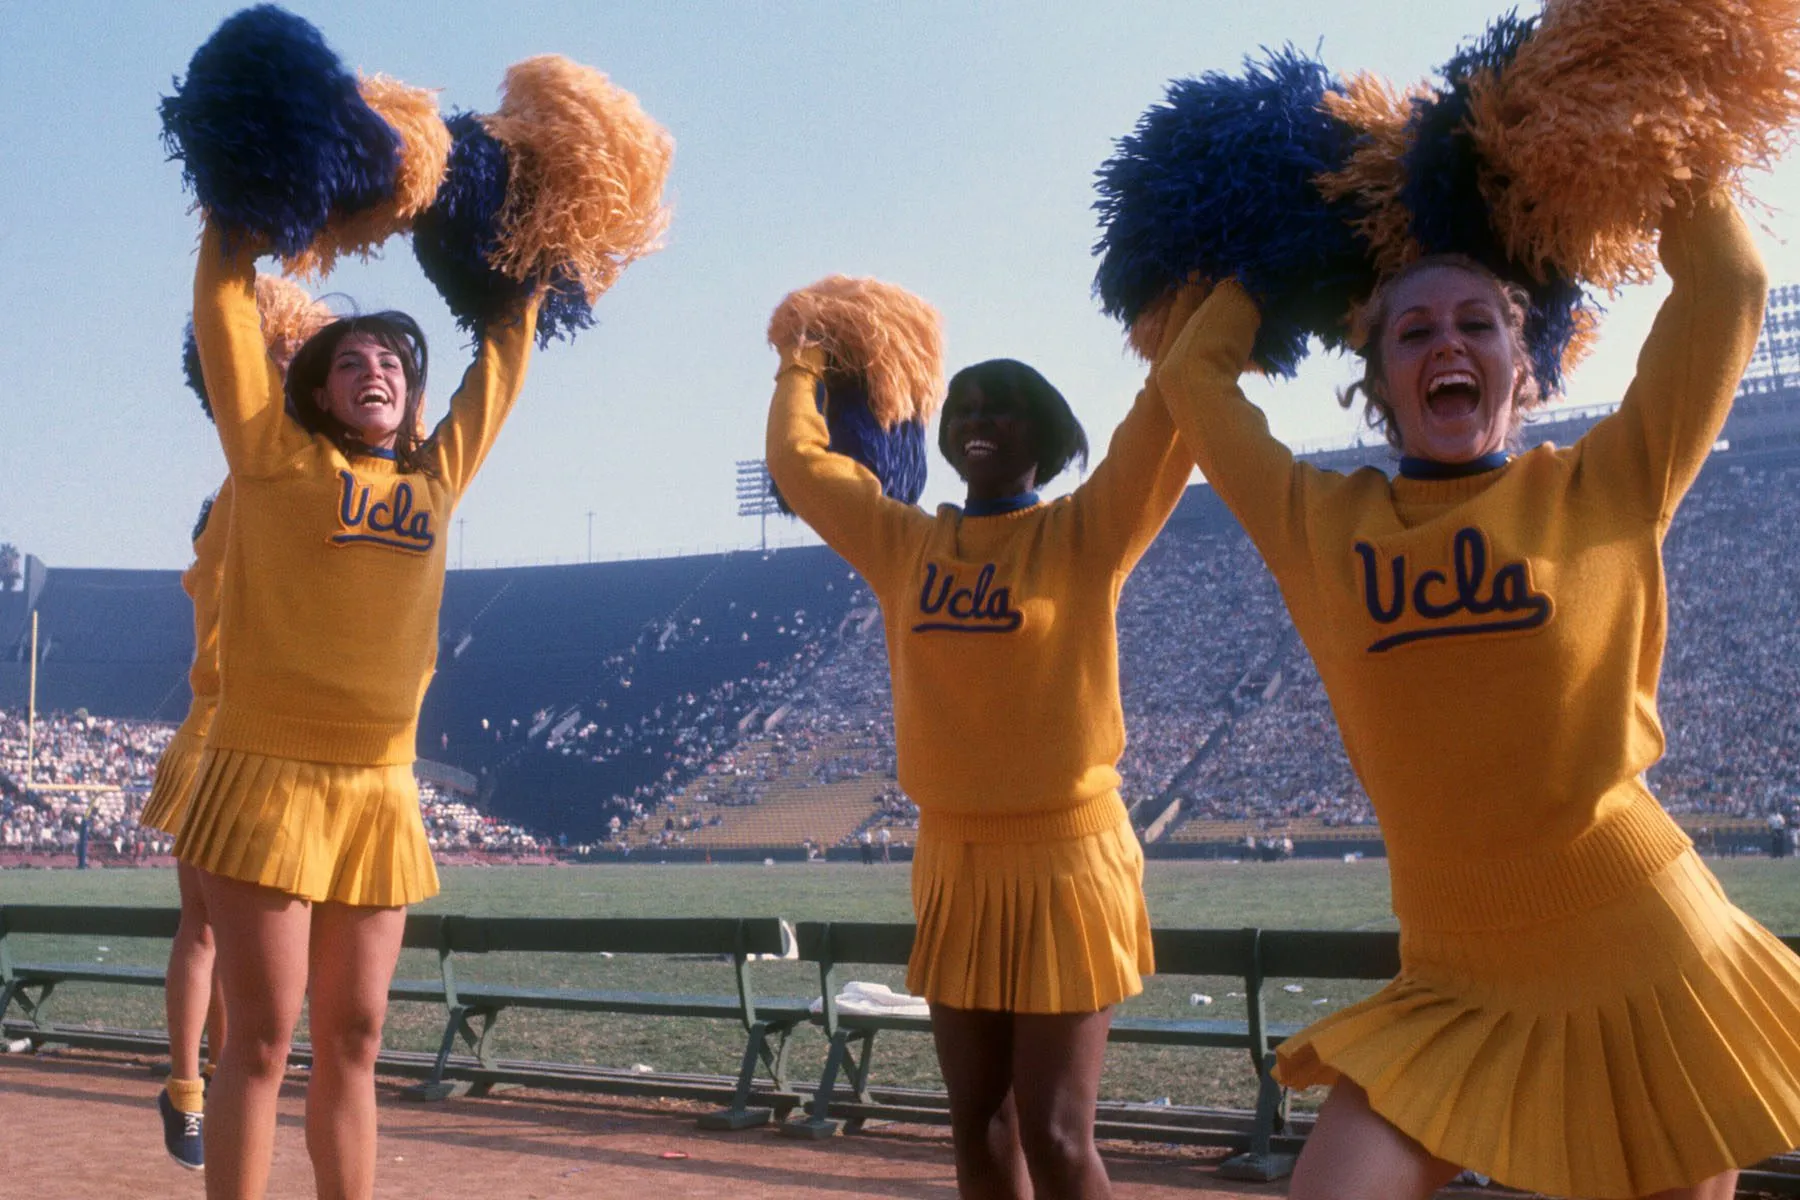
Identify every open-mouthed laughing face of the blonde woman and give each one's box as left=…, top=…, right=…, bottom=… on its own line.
left=1381, top=266, right=1528, bottom=462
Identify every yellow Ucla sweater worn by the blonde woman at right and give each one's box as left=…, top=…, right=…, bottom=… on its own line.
left=1157, top=200, right=1766, bottom=925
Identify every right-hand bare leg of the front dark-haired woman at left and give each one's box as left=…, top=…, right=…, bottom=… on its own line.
left=306, top=903, right=407, bottom=1200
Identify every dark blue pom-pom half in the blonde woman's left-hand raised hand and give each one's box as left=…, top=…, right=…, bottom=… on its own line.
left=1094, top=49, right=1375, bottom=376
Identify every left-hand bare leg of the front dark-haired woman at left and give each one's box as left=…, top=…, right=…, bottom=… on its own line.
left=198, top=871, right=311, bottom=1200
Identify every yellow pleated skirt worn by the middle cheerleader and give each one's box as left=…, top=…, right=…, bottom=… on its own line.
left=907, top=793, right=1156, bottom=1013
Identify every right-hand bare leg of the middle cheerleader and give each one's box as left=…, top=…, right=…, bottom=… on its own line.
left=1013, top=1007, right=1112, bottom=1200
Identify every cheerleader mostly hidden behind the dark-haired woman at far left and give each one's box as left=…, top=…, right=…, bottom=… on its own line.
left=139, top=479, right=230, bottom=1171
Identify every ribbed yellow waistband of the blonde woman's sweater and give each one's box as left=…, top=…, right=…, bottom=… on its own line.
left=1391, top=792, right=1694, bottom=932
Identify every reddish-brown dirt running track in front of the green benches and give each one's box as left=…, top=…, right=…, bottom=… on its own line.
left=0, top=1051, right=1353, bottom=1200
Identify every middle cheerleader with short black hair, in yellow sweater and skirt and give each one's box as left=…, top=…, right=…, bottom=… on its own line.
left=767, top=293, right=1190, bottom=1196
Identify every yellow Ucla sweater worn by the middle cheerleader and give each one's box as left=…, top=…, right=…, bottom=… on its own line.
left=767, top=351, right=1192, bottom=835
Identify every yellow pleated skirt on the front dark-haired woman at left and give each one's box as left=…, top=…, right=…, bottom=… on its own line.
left=175, top=748, right=437, bottom=909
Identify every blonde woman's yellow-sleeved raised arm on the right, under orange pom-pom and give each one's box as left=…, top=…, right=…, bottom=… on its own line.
left=1580, top=193, right=1769, bottom=522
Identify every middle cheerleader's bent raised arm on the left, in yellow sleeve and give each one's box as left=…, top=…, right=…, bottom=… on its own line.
left=765, top=345, right=931, bottom=596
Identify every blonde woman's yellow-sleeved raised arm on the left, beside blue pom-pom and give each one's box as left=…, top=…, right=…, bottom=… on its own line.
left=1156, top=281, right=1316, bottom=575
